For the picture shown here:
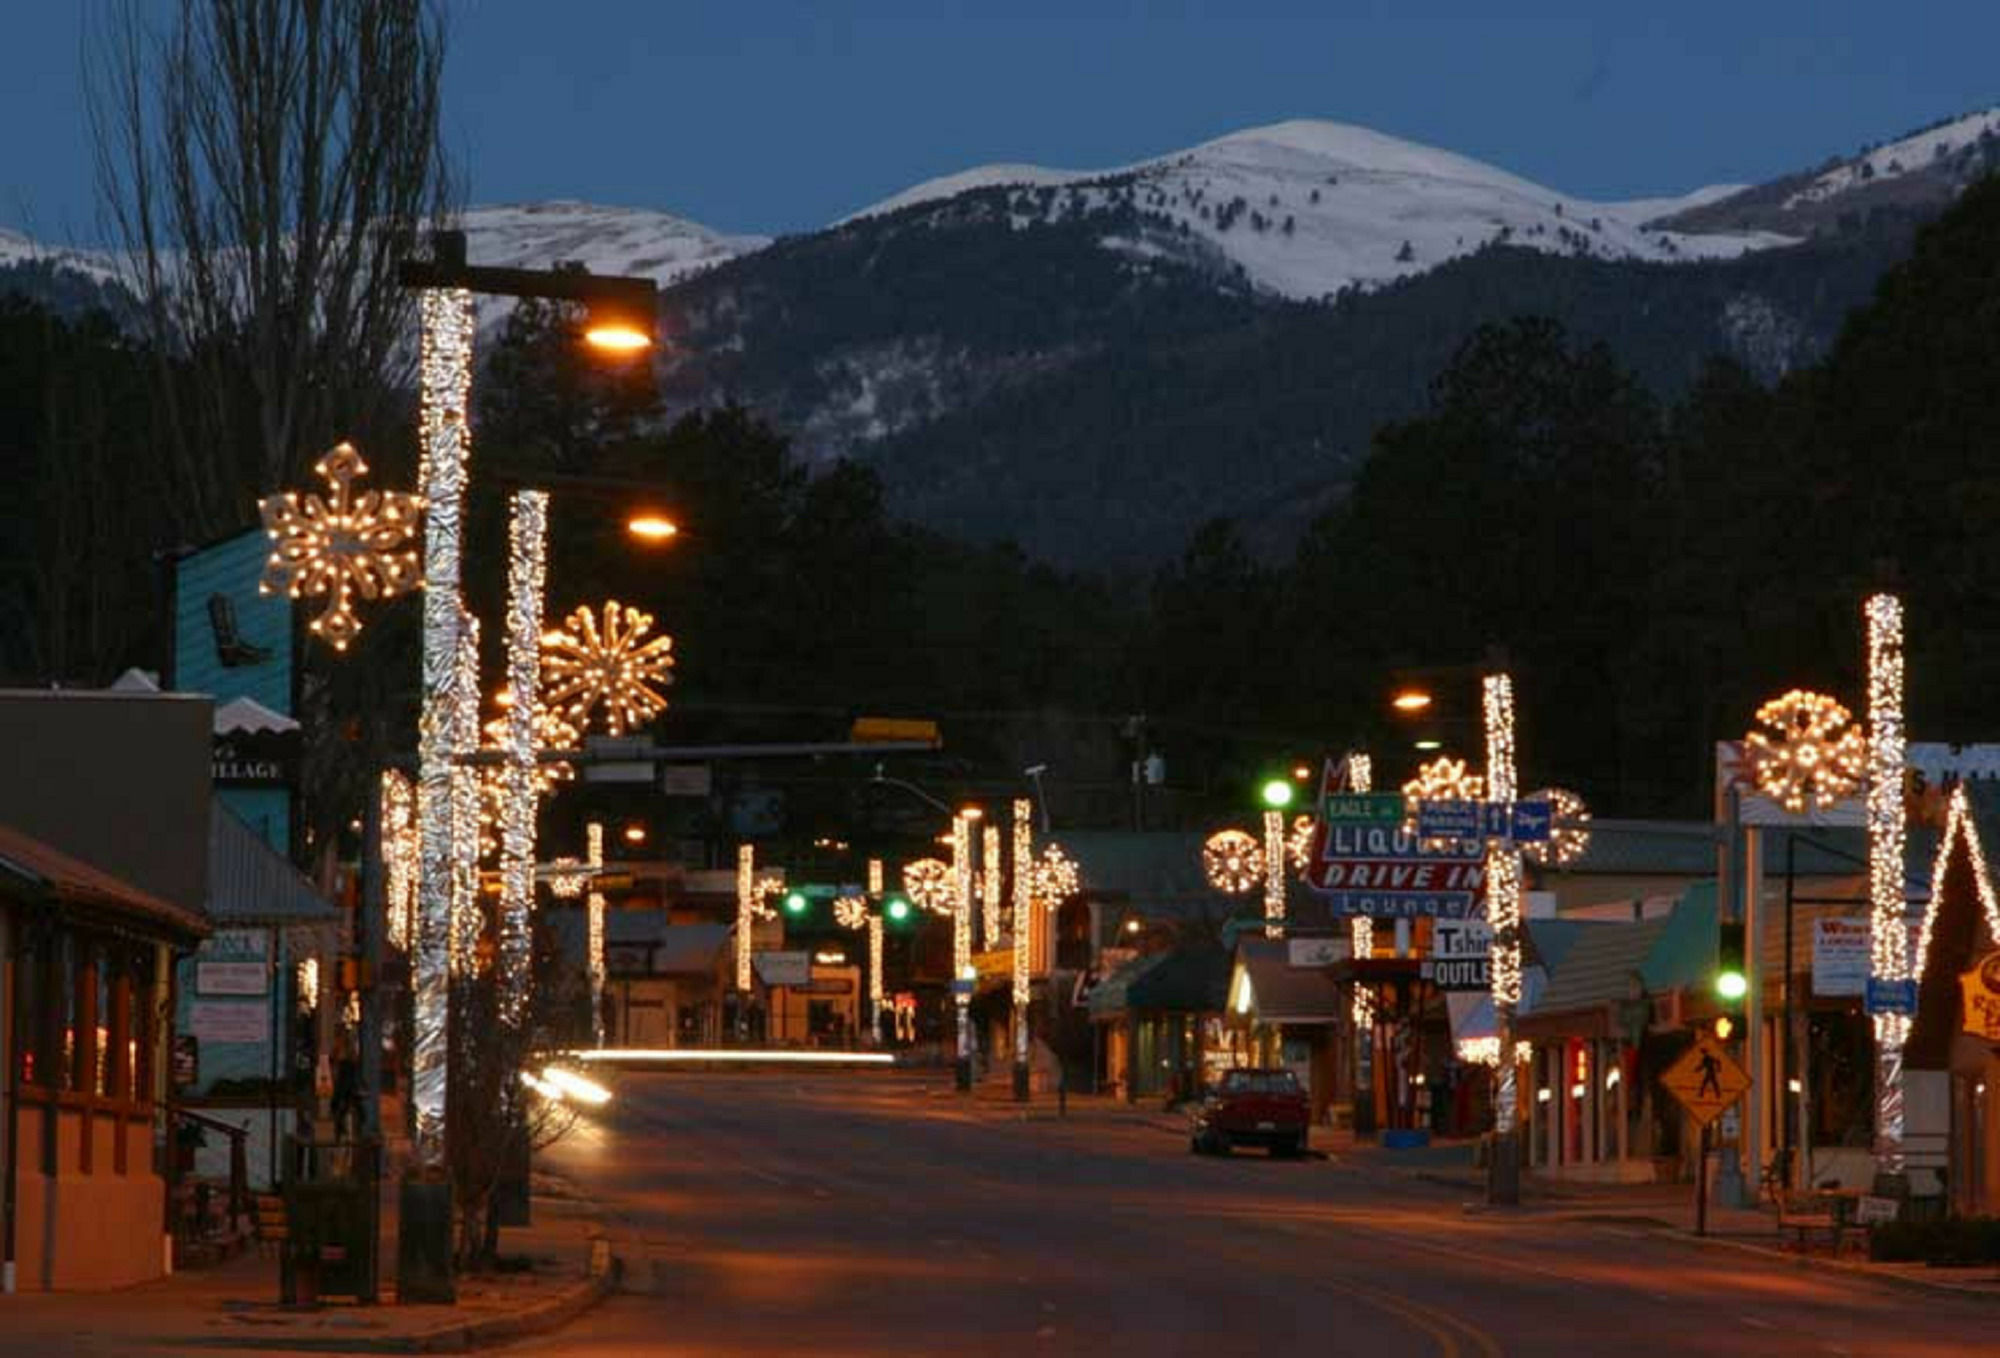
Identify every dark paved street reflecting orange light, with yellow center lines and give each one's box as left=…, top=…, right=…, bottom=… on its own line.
left=514, top=1072, right=2000, bottom=1358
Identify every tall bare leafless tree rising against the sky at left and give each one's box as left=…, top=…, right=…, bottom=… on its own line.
left=90, top=0, right=450, bottom=542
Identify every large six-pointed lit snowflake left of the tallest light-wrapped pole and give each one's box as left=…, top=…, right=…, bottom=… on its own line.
left=256, top=442, right=424, bottom=650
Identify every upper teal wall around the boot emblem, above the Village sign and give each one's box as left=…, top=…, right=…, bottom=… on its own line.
left=174, top=528, right=292, bottom=716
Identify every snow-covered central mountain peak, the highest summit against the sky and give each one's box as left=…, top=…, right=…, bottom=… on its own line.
left=836, top=120, right=1794, bottom=300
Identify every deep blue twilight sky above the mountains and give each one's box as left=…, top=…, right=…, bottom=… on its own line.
left=0, top=0, right=2000, bottom=242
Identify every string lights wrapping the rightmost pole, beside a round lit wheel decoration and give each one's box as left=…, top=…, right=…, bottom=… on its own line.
left=1862, top=594, right=1910, bottom=1174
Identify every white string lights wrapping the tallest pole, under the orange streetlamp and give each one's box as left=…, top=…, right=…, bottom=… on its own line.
left=410, top=288, right=478, bottom=1166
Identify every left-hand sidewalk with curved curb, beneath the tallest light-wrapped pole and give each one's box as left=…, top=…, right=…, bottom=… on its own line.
left=0, top=1176, right=618, bottom=1354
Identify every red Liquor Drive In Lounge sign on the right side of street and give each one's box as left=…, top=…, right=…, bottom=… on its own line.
left=1306, top=822, right=1486, bottom=920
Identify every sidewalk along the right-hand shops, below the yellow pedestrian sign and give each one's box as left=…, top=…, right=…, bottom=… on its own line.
left=1332, top=1144, right=2000, bottom=1302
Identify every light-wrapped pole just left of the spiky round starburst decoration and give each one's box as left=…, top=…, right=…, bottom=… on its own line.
left=496, top=490, right=548, bottom=1028
